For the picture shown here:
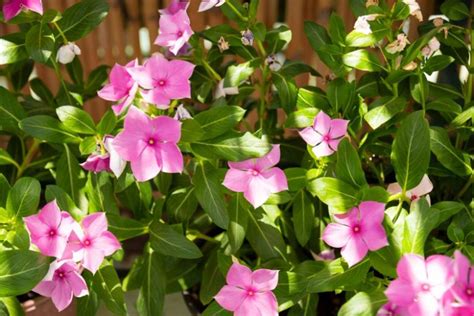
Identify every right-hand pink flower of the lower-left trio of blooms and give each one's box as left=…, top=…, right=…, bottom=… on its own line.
left=65, top=212, right=121, bottom=273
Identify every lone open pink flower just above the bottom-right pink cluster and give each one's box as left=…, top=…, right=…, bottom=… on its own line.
left=323, top=201, right=388, bottom=266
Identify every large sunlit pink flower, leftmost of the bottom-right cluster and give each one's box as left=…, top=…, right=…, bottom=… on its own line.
left=385, top=254, right=452, bottom=316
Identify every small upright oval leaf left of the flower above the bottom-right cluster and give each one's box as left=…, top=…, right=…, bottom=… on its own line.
left=293, top=190, right=315, bottom=246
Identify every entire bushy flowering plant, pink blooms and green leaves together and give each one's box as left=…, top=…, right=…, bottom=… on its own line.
left=0, top=0, right=474, bottom=316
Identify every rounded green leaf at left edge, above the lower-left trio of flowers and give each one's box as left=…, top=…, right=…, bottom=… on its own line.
left=7, top=178, right=41, bottom=219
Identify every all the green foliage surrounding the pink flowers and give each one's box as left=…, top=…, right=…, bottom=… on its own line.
left=0, top=0, right=474, bottom=315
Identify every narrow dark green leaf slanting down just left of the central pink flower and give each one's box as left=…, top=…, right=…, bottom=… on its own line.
left=193, top=163, right=229, bottom=229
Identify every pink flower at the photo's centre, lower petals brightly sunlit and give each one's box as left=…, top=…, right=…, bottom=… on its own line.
left=223, top=145, right=288, bottom=208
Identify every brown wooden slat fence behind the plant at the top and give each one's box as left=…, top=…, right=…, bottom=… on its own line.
left=0, top=0, right=435, bottom=119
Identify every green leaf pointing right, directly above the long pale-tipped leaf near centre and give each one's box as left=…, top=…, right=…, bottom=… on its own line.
left=193, top=106, right=245, bottom=139
